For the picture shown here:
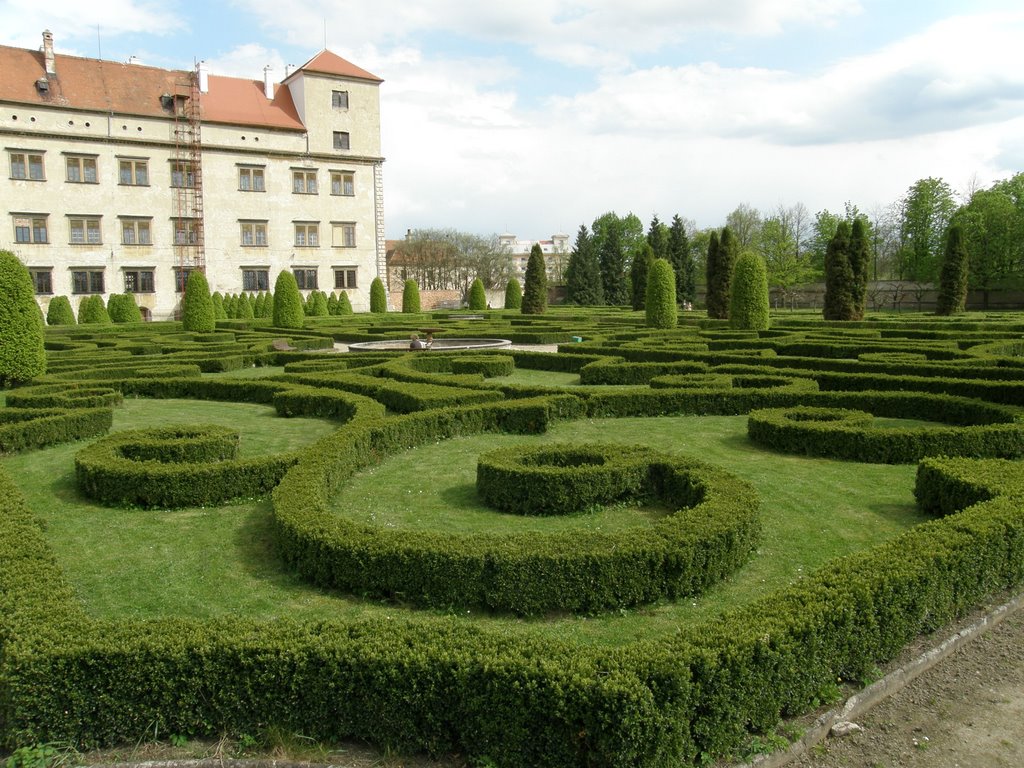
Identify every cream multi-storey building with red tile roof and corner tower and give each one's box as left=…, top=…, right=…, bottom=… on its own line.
left=0, top=32, right=386, bottom=319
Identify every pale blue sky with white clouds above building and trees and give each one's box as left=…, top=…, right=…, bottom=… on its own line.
left=0, top=0, right=1024, bottom=240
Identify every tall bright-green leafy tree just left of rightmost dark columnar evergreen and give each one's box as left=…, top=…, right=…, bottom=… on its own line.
left=898, top=178, right=956, bottom=283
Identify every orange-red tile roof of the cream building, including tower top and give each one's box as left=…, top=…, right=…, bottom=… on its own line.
left=0, top=45, right=383, bottom=130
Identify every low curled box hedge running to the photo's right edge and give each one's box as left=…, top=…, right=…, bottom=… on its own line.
left=746, top=406, right=1024, bottom=464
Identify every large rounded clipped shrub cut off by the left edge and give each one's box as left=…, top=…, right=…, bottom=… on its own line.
left=0, top=251, right=46, bottom=387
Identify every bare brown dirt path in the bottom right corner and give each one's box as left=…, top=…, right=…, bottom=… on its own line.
left=790, top=610, right=1024, bottom=768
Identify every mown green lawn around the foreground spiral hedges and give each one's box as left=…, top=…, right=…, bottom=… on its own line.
left=3, top=399, right=922, bottom=644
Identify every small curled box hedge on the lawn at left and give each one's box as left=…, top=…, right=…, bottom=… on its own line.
left=75, top=425, right=298, bottom=508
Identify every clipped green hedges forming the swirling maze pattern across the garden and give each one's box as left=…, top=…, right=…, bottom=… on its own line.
left=0, top=310, right=1024, bottom=767
